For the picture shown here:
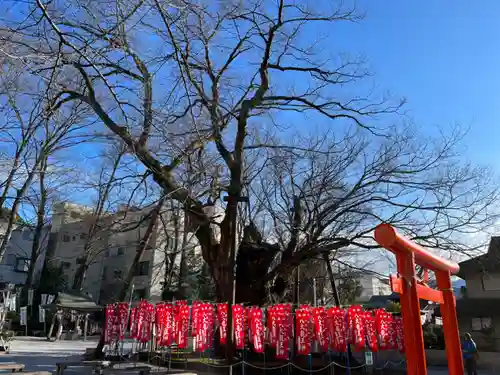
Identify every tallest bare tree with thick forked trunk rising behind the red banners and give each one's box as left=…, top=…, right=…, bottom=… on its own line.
left=2, top=1, right=386, bottom=299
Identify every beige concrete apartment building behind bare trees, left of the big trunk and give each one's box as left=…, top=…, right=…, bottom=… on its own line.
left=47, top=203, right=196, bottom=303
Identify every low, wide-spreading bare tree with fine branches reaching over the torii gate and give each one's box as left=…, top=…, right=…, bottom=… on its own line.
left=238, top=129, right=499, bottom=300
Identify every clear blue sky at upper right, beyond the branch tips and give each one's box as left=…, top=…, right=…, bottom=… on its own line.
left=340, top=0, right=500, bottom=166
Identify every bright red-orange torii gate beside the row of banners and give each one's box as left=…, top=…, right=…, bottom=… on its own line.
left=375, top=224, right=464, bottom=375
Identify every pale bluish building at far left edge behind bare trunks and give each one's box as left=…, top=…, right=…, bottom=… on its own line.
left=0, top=226, right=50, bottom=285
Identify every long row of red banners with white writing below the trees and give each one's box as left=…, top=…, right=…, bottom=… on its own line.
left=105, top=300, right=404, bottom=359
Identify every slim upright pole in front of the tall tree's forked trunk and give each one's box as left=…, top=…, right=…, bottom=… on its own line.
left=223, top=193, right=248, bottom=375
